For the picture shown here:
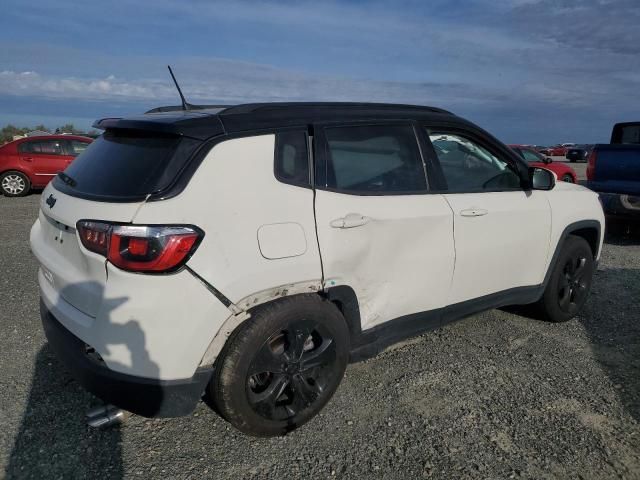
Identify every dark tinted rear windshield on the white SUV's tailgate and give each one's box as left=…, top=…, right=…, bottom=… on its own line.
left=54, top=130, right=200, bottom=201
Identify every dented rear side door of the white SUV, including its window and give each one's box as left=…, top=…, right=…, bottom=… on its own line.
left=314, top=123, right=454, bottom=330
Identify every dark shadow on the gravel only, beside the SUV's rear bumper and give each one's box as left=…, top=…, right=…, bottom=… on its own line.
left=6, top=345, right=123, bottom=479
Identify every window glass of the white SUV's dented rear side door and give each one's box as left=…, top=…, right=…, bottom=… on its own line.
left=324, top=125, right=427, bottom=194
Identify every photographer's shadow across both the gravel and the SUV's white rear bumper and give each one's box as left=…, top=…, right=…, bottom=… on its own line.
left=5, top=282, right=161, bottom=479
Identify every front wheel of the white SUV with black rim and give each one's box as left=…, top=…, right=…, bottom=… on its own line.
left=538, top=235, right=594, bottom=322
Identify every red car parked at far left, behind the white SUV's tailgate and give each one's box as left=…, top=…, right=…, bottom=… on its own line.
left=0, top=135, right=93, bottom=197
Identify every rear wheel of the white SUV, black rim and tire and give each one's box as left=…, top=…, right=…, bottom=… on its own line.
left=207, top=294, right=349, bottom=437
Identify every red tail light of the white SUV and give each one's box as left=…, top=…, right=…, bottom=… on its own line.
left=76, top=220, right=204, bottom=273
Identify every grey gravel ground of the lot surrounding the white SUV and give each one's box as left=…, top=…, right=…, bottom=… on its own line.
left=0, top=195, right=640, bottom=479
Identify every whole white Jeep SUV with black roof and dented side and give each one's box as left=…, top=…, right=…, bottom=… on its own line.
left=31, top=103, right=604, bottom=436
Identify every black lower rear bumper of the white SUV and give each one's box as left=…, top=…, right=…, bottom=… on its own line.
left=40, top=301, right=212, bottom=417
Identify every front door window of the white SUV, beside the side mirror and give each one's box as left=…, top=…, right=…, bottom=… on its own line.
left=429, top=131, right=520, bottom=192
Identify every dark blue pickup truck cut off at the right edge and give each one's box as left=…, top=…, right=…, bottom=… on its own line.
left=587, top=122, right=640, bottom=222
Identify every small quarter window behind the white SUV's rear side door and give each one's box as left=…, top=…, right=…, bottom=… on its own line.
left=274, top=130, right=311, bottom=187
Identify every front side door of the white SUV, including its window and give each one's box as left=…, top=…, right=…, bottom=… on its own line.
left=426, top=126, right=551, bottom=305
